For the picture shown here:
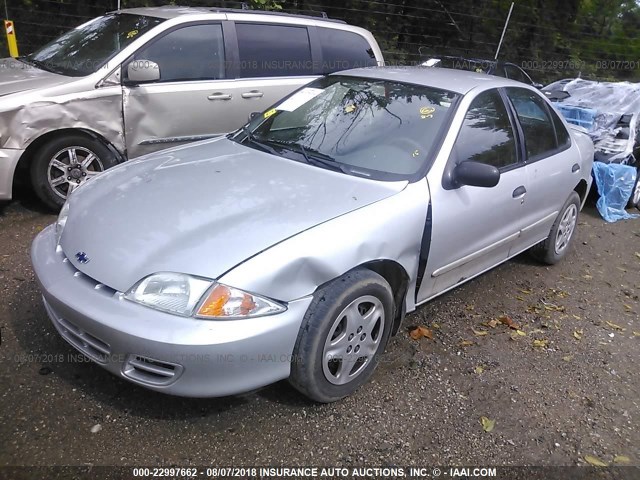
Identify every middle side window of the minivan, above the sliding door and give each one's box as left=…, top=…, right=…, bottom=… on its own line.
left=236, top=23, right=313, bottom=78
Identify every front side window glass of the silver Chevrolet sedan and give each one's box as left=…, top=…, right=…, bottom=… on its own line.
left=455, top=90, right=518, bottom=168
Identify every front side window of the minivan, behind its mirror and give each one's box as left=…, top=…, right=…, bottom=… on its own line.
left=134, top=24, right=225, bottom=82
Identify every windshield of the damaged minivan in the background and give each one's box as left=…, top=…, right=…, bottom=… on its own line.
left=20, top=13, right=164, bottom=77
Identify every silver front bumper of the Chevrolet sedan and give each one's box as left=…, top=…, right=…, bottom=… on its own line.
left=31, top=226, right=312, bottom=397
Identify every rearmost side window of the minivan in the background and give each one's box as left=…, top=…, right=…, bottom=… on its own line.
left=318, top=28, right=378, bottom=74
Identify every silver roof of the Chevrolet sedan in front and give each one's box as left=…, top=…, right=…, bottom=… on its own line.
left=340, top=66, right=526, bottom=95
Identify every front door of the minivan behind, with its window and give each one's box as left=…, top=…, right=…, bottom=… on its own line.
left=122, top=22, right=234, bottom=158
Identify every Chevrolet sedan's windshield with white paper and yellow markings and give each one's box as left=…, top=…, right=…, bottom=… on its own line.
left=231, top=75, right=458, bottom=180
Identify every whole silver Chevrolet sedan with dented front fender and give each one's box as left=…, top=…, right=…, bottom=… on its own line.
left=32, top=68, right=593, bottom=402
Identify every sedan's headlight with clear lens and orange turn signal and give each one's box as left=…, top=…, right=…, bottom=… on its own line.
left=125, top=272, right=286, bottom=319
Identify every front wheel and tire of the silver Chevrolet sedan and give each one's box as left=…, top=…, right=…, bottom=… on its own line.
left=289, top=269, right=394, bottom=403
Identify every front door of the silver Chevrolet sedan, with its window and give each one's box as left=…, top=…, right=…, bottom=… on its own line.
left=417, top=89, right=527, bottom=302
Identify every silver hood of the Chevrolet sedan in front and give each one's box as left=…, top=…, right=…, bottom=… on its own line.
left=61, top=138, right=407, bottom=291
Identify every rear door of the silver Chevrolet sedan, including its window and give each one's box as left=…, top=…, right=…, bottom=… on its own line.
left=506, top=87, right=581, bottom=254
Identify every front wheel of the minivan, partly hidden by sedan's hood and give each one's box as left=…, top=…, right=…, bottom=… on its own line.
left=31, top=135, right=118, bottom=211
